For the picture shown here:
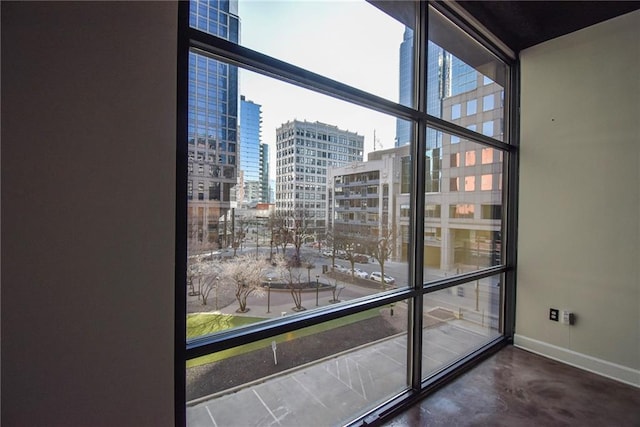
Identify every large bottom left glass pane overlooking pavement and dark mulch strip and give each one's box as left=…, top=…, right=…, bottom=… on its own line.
left=187, top=301, right=407, bottom=426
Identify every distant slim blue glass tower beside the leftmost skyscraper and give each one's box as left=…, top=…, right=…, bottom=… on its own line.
left=237, top=95, right=265, bottom=205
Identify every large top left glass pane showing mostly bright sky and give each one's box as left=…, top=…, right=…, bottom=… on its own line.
left=190, top=0, right=415, bottom=106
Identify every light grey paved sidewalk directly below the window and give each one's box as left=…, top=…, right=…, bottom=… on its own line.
left=187, top=310, right=492, bottom=427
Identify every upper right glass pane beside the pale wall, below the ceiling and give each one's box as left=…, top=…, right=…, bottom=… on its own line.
left=427, top=5, right=507, bottom=141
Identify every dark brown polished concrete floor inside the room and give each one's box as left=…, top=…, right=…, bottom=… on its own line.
left=385, top=346, right=640, bottom=427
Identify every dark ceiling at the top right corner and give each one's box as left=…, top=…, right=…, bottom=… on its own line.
left=458, top=0, right=640, bottom=53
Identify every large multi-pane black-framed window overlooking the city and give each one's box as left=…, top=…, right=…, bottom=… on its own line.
left=176, top=0, right=516, bottom=426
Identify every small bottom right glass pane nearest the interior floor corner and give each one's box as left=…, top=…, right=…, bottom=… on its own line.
left=422, top=275, right=503, bottom=378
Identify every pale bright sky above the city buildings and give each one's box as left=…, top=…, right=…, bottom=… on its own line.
left=238, top=0, right=404, bottom=179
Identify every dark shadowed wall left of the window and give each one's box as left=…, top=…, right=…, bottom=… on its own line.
left=2, top=2, right=177, bottom=427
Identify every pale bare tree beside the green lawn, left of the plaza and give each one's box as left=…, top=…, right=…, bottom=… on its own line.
left=219, top=255, right=269, bottom=313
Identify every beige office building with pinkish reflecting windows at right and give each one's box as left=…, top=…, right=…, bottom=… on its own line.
left=425, top=72, right=504, bottom=270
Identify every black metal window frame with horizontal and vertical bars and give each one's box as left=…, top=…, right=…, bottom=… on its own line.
left=174, top=2, right=519, bottom=426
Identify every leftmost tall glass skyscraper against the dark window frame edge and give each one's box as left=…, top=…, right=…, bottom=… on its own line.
left=187, top=0, right=239, bottom=247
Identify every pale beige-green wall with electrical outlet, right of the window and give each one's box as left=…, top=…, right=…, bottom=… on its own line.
left=516, top=12, right=640, bottom=386
